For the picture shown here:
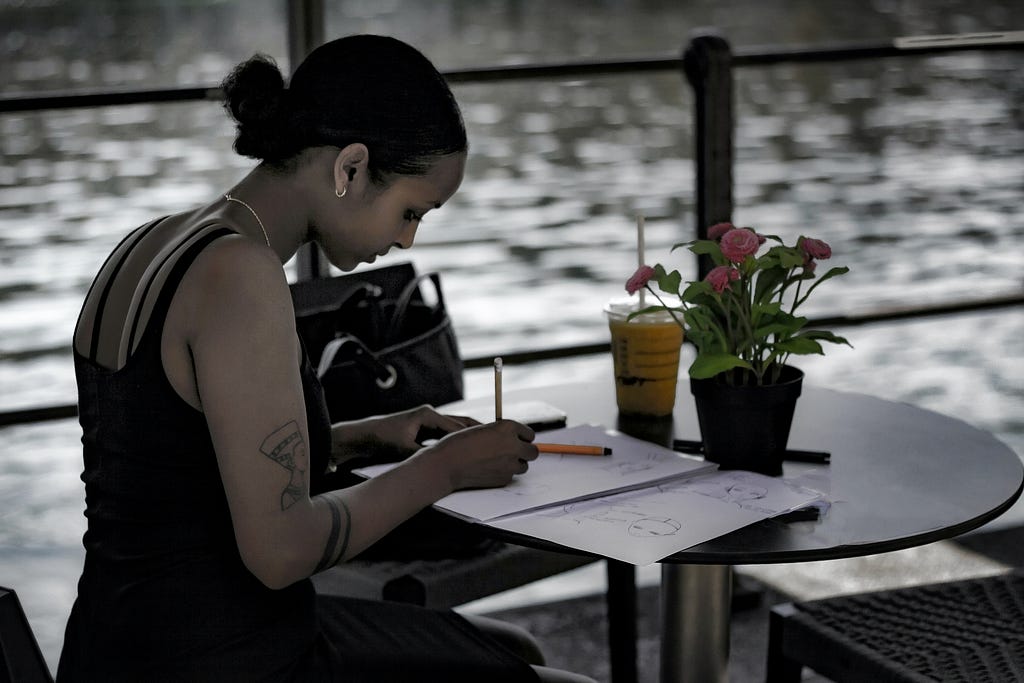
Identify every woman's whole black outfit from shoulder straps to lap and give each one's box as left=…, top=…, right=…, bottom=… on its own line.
left=57, top=224, right=539, bottom=683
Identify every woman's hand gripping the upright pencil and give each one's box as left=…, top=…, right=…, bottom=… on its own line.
left=418, top=420, right=538, bottom=490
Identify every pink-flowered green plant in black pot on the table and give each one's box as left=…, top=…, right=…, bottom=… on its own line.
left=626, top=222, right=849, bottom=475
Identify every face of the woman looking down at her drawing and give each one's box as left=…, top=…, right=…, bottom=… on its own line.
left=313, top=153, right=466, bottom=270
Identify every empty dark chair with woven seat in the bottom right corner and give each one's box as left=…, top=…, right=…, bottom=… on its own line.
left=767, top=570, right=1024, bottom=683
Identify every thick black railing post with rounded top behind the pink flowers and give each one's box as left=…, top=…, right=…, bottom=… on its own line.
left=683, top=33, right=735, bottom=280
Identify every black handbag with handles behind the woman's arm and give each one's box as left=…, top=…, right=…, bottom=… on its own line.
left=292, top=263, right=463, bottom=422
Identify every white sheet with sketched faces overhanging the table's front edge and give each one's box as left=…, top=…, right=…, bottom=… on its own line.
left=487, top=470, right=820, bottom=565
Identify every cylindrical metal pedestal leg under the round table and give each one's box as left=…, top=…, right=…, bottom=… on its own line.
left=660, top=563, right=732, bottom=683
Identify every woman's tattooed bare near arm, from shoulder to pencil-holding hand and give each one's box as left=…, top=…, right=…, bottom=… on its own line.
left=174, top=239, right=537, bottom=588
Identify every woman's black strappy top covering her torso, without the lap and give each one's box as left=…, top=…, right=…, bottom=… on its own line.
left=57, top=226, right=330, bottom=681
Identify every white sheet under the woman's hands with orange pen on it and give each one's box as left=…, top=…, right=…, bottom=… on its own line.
left=355, top=425, right=717, bottom=521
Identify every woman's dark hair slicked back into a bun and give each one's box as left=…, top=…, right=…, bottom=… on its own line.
left=221, top=35, right=468, bottom=183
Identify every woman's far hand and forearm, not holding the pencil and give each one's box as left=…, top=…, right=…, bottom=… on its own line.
left=331, top=405, right=479, bottom=464
